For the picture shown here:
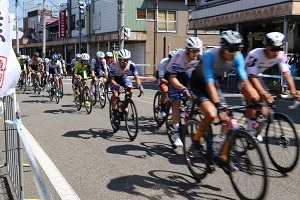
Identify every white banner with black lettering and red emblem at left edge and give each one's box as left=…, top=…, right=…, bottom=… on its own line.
left=0, top=0, right=21, bottom=97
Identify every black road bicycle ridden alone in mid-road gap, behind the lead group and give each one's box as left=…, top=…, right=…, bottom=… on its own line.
left=109, top=87, right=143, bottom=141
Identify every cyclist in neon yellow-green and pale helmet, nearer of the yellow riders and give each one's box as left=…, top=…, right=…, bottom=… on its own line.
left=74, top=53, right=90, bottom=98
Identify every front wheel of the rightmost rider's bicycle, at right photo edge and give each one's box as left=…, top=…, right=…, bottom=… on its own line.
left=266, top=113, right=299, bottom=173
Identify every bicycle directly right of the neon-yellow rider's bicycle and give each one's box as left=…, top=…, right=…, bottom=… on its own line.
left=91, top=76, right=106, bottom=108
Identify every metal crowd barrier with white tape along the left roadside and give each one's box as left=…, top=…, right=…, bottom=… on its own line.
left=3, top=93, right=52, bottom=200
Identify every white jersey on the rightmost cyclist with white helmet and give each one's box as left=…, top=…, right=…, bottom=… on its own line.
left=245, top=48, right=289, bottom=76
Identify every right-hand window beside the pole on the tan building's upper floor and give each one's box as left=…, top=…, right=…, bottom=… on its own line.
left=157, top=10, right=177, bottom=32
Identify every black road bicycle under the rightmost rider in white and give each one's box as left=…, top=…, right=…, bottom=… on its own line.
left=233, top=95, right=300, bottom=173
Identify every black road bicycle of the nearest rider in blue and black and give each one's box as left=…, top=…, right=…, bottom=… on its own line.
left=182, top=104, right=268, bottom=200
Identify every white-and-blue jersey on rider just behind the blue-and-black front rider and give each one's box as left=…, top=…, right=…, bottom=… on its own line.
left=166, top=50, right=202, bottom=75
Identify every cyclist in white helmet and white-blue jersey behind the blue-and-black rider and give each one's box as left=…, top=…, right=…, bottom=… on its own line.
left=167, top=37, right=202, bottom=147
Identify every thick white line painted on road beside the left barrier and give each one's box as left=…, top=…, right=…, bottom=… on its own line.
left=21, top=124, right=80, bottom=200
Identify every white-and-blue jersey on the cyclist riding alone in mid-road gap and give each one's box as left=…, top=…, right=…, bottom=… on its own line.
left=110, top=60, right=139, bottom=77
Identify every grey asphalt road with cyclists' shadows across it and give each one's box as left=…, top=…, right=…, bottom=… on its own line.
left=4, top=79, right=300, bottom=200
